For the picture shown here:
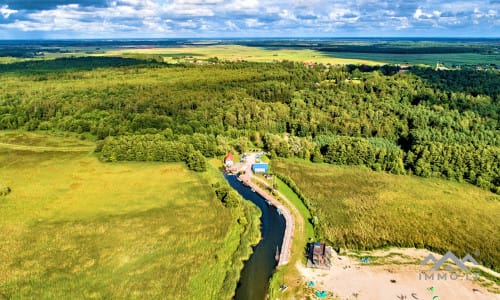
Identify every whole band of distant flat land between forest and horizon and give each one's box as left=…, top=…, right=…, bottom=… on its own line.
left=0, top=38, right=500, bottom=66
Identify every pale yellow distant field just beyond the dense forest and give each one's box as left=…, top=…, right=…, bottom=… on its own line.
left=105, top=45, right=382, bottom=65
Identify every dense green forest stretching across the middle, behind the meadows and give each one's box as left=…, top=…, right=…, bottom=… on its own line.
left=0, top=57, right=500, bottom=193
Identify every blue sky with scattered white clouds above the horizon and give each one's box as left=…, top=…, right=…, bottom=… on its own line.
left=0, top=0, right=500, bottom=39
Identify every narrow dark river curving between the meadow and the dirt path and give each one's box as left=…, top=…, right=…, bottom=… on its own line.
left=226, top=176, right=285, bottom=300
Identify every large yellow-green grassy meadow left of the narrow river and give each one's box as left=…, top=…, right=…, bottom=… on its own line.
left=0, top=132, right=258, bottom=299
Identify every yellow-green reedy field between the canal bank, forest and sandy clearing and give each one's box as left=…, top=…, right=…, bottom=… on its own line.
left=272, top=161, right=500, bottom=270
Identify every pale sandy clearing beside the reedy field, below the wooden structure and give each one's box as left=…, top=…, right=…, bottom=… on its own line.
left=297, top=249, right=500, bottom=300
